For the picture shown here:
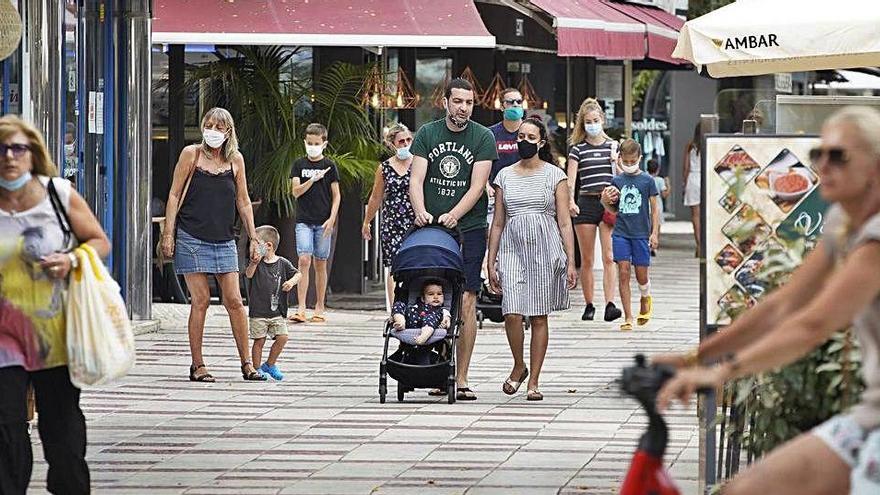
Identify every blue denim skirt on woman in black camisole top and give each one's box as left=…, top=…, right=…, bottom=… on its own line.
left=174, top=229, right=238, bottom=275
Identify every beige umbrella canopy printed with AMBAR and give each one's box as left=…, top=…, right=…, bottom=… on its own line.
left=672, top=0, right=880, bottom=77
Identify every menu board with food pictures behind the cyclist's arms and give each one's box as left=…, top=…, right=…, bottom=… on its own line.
left=702, top=135, right=828, bottom=330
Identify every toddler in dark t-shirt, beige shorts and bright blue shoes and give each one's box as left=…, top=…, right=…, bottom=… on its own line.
left=244, top=225, right=300, bottom=380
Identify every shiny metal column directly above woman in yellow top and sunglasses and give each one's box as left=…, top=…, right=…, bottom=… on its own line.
left=22, top=0, right=64, bottom=167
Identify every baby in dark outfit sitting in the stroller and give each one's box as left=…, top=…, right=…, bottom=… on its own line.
left=391, top=279, right=451, bottom=345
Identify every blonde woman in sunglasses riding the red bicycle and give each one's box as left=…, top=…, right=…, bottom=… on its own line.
left=654, top=107, right=880, bottom=495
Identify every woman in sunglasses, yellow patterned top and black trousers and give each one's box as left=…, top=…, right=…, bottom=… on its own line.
left=0, top=116, right=110, bottom=494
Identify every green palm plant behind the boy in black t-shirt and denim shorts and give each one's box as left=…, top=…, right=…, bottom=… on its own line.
left=187, top=46, right=382, bottom=216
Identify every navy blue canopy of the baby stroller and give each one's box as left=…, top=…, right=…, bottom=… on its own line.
left=391, top=227, right=463, bottom=277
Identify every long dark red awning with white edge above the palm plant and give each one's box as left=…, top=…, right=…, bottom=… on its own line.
left=153, top=0, right=495, bottom=48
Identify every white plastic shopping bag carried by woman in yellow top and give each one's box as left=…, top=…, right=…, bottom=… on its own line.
left=67, top=244, right=135, bottom=388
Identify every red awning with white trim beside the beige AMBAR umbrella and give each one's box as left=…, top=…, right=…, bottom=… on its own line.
left=531, top=0, right=684, bottom=63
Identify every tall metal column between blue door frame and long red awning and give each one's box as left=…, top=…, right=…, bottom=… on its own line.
left=117, top=0, right=153, bottom=320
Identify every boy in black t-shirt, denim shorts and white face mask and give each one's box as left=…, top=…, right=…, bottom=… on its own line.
left=290, top=124, right=340, bottom=323
